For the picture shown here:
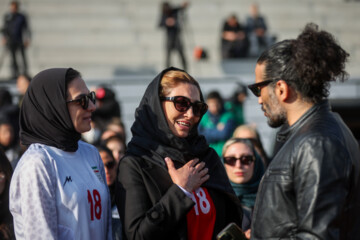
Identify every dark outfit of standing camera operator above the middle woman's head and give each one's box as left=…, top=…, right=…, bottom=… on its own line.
left=159, top=8, right=187, bottom=70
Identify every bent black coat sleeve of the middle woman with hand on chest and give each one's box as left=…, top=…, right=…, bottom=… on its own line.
left=116, top=158, right=194, bottom=240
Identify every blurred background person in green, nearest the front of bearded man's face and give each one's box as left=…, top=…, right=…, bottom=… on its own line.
left=225, top=82, right=248, bottom=126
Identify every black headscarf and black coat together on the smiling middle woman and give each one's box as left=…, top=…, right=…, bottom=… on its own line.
left=116, top=68, right=242, bottom=240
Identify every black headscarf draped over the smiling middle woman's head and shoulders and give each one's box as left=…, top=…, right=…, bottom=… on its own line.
left=126, top=67, right=233, bottom=193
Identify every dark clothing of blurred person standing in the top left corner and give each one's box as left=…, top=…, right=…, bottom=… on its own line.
left=3, top=12, right=30, bottom=77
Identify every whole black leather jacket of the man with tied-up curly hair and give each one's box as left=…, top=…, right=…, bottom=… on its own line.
left=251, top=101, right=360, bottom=240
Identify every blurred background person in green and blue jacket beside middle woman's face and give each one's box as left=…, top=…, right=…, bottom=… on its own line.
left=199, top=91, right=236, bottom=156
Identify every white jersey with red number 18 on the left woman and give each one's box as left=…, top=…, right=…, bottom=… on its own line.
left=10, top=141, right=112, bottom=240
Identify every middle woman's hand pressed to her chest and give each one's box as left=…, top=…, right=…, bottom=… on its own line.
left=165, top=157, right=210, bottom=192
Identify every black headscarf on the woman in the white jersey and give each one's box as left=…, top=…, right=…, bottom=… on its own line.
left=20, top=68, right=81, bottom=152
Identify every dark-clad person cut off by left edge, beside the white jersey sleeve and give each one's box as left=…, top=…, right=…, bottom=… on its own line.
left=0, top=149, right=15, bottom=240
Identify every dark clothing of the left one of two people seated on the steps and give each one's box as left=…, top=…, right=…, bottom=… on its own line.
left=221, top=21, right=249, bottom=59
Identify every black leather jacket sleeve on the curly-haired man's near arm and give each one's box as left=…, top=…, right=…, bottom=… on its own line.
left=294, top=137, right=351, bottom=239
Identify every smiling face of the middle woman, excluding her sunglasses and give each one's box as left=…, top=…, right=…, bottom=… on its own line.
left=162, top=82, right=200, bottom=138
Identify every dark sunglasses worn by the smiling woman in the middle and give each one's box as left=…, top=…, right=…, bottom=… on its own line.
left=160, top=96, right=208, bottom=117
